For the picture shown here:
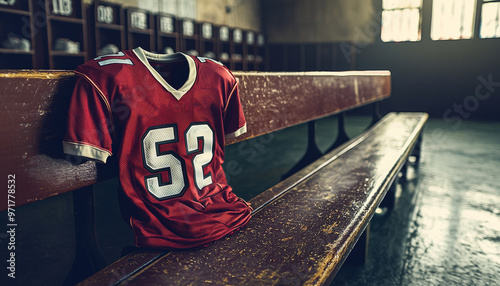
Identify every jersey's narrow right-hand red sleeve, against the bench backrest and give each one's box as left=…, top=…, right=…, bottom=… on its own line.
left=224, top=82, right=247, bottom=138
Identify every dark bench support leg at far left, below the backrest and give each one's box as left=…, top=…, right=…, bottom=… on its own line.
left=64, top=186, right=106, bottom=285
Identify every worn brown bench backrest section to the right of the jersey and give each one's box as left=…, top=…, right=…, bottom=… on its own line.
left=227, top=71, right=391, bottom=143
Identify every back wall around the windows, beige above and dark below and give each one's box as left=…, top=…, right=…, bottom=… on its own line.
left=263, top=0, right=500, bottom=120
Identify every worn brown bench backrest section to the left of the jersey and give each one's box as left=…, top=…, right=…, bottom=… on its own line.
left=0, top=71, right=103, bottom=211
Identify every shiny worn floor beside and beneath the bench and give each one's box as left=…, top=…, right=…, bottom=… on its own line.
left=0, top=116, right=500, bottom=285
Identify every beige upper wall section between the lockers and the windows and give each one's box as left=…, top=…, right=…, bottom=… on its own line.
left=262, top=0, right=374, bottom=43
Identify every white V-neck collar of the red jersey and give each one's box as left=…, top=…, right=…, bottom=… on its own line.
left=132, top=47, right=196, bottom=100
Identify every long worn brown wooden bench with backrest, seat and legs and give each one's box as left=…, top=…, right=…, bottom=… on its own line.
left=0, top=68, right=427, bottom=285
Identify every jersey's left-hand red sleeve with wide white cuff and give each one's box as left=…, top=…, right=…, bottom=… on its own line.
left=63, top=73, right=113, bottom=163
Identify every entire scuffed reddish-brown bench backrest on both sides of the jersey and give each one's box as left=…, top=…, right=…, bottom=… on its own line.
left=0, top=70, right=391, bottom=211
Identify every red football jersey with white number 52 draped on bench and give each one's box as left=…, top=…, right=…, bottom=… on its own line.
left=63, top=48, right=252, bottom=248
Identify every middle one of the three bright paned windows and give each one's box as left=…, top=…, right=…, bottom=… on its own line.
left=431, top=0, right=476, bottom=40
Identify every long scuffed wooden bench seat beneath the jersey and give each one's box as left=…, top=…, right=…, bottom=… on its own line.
left=101, top=113, right=427, bottom=285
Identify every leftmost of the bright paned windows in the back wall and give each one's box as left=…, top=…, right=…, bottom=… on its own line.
left=381, top=0, right=422, bottom=42
